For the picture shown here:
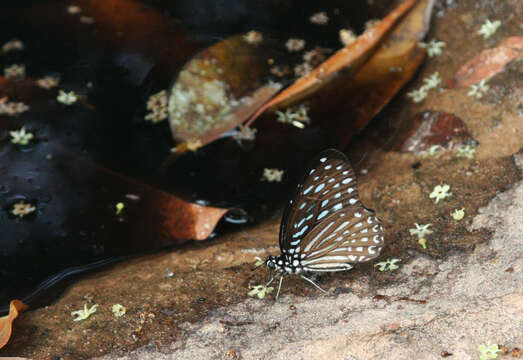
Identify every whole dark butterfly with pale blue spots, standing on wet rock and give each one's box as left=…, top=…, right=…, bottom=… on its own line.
left=265, top=149, right=384, bottom=299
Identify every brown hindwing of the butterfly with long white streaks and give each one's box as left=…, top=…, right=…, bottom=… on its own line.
left=300, top=206, right=384, bottom=271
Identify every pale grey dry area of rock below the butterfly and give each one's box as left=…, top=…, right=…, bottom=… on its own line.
left=100, top=154, right=523, bottom=360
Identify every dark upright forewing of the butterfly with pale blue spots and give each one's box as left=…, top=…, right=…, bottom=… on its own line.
left=280, top=149, right=362, bottom=253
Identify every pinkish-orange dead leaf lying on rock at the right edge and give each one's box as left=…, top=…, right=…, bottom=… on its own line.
left=450, top=36, right=523, bottom=88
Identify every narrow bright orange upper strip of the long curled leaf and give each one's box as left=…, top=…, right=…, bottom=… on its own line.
left=245, top=0, right=416, bottom=126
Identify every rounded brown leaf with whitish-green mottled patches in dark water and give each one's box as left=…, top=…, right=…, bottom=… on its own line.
left=169, top=35, right=281, bottom=152
